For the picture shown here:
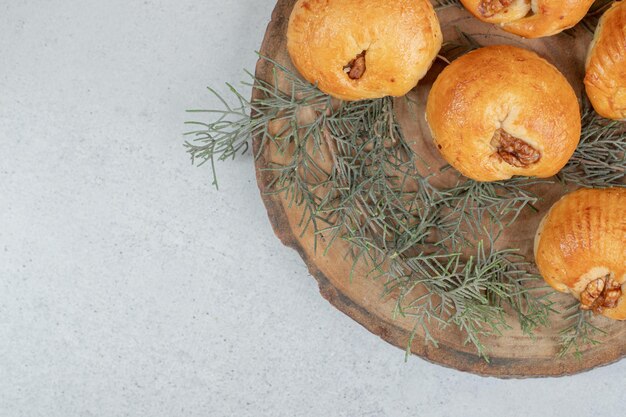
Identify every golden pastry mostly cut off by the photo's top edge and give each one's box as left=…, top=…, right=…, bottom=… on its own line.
left=461, top=0, right=594, bottom=38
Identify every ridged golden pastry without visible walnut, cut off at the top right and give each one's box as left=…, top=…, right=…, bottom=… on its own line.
left=585, top=1, right=626, bottom=120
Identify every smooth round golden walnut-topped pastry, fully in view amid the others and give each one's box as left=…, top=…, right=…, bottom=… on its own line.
left=426, top=45, right=581, bottom=181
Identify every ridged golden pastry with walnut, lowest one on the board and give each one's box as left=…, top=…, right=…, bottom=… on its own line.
left=535, top=188, right=626, bottom=320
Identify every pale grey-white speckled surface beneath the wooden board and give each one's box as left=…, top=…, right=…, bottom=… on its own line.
left=0, top=0, right=626, bottom=417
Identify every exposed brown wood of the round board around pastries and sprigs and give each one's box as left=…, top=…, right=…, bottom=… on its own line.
left=253, top=0, right=626, bottom=378
